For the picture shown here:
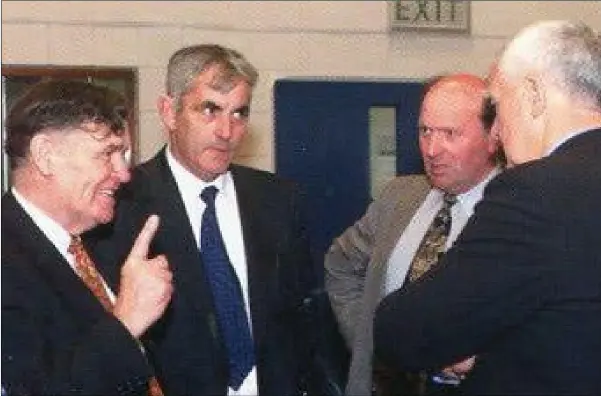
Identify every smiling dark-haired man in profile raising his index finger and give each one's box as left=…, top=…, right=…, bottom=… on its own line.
left=2, top=81, right=171, bottom=396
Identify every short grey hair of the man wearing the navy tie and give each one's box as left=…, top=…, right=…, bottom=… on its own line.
left=166, top=44, right=259, bottom=111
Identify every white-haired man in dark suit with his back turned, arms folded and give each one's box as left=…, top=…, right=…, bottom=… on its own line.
left=375, top=21, right=601, bottom=395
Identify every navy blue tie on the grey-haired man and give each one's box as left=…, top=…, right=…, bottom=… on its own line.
left=200, top=186, right=255, bottom=390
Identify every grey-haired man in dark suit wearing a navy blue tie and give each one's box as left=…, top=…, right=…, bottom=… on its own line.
left=91, top=44, right=340, bottom=396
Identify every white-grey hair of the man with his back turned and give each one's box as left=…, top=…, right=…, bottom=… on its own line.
left=499, top=21, right=601, bottom=107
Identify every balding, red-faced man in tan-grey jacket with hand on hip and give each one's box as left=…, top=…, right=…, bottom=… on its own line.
left=325, top=74, right=499, bottom=396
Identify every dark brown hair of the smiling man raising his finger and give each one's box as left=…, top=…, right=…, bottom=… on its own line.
left=4, top=79, right=128, bottom=167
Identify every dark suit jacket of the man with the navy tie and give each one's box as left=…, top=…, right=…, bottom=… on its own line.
left=90, top=150, right=318, bottom=396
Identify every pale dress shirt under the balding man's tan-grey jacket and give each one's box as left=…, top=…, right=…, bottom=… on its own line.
left=382, top=168, right=500, bottom=295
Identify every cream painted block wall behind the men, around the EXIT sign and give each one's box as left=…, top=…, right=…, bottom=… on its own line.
left=2, top=0, right=601, bottom=170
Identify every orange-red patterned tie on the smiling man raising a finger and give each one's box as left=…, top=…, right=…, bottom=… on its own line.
left=67, top=235, right=163, bottom=396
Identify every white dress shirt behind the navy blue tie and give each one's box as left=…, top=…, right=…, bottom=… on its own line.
left=166, top=147, right=258, bottom=396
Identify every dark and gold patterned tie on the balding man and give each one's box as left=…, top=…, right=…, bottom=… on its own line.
left=409, top=194, right=457, bottom=282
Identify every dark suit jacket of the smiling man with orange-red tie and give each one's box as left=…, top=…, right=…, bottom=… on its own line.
left=2, top=193, right=155, bottom=396
